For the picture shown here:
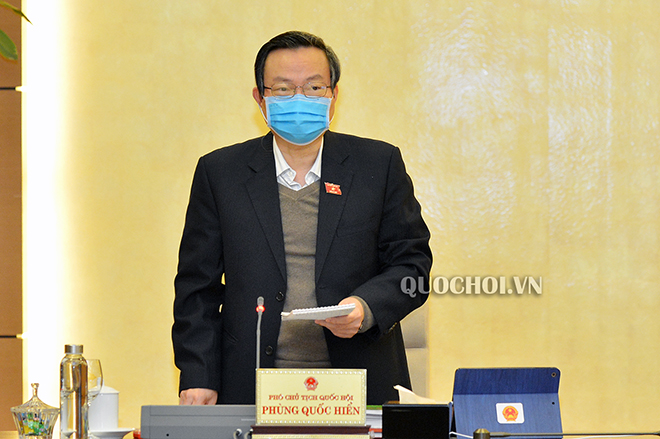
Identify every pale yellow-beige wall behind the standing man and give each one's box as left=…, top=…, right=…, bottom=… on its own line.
left=24, top=0, right=660, bottom=431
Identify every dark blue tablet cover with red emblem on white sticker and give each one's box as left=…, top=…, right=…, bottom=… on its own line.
left=453, top=367, right=562, bottom=438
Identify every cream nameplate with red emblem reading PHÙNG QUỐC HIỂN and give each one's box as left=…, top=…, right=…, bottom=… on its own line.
left=256, top=369, right=367, bottom=425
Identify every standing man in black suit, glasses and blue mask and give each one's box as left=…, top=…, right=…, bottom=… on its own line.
left=172, top=32, right=431, bottom=404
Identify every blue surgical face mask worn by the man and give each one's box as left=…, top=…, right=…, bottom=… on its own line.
left=264, top=94, right=332, bottom=145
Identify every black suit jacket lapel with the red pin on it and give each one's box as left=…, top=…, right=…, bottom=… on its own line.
left=315, top=132, right=353, bottom=282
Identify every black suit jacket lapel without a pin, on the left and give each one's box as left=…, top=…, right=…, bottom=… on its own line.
left=246, top=133, right=286, bottom=281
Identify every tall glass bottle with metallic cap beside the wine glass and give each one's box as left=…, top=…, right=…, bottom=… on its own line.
left=60, top=344, right=89, bottom=439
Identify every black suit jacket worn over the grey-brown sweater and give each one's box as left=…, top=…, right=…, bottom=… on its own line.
left=172, top=132, right=431, bottom=404
